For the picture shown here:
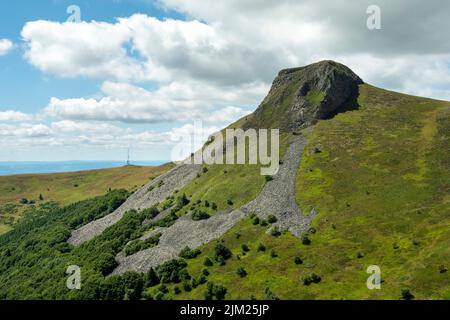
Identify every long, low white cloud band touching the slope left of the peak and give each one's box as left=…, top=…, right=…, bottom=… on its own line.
left=44, top=82, right=266, bottom=124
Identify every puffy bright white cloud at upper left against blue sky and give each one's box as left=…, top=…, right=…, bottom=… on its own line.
left=22, top=20, right=146, bottom=81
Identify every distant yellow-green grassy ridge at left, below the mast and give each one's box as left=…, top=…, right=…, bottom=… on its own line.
left=0, top=164, right=173, bottom=234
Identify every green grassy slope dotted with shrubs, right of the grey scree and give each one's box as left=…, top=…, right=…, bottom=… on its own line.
left=153, top=85, right=450, bottom=299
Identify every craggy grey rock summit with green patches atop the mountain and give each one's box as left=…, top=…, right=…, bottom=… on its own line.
left=244, top=61, right=363, bottom=131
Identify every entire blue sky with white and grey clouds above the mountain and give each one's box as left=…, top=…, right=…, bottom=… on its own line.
left=0, top=0, right=450, bottom=161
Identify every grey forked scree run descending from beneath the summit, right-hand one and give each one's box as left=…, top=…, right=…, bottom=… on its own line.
left=113, top=136, right=315, bottom=274
